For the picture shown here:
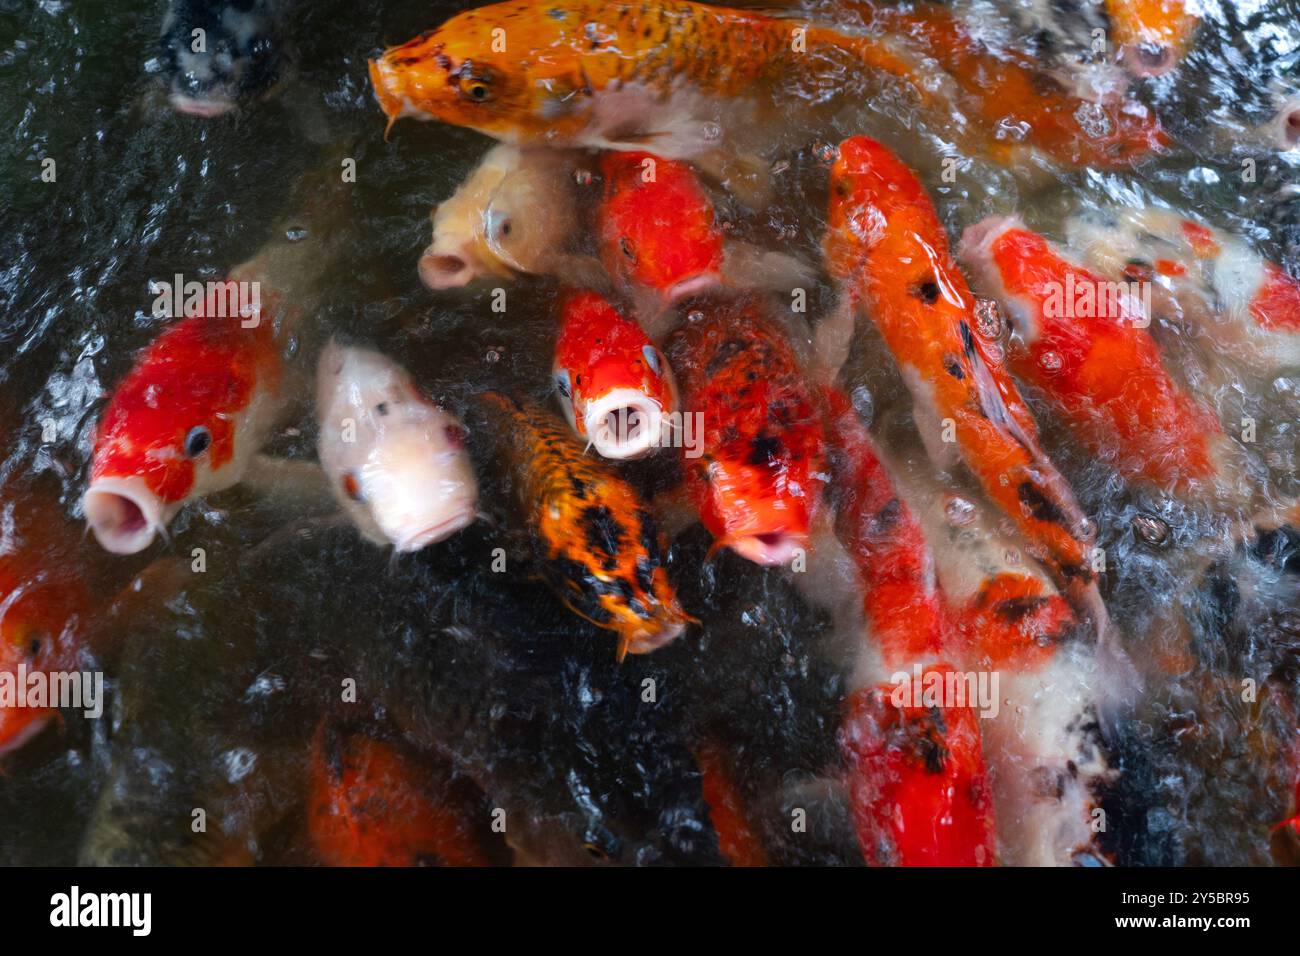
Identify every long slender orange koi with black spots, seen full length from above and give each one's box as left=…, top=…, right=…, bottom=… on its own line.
left=824, top=137, right=1093, bottom=591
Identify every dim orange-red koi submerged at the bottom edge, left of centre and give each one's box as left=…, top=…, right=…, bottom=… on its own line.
left=307, top=722, right=489, bottom=866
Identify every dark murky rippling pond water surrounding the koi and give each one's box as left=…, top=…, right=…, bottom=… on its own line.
left=0, top=0, right=1300, bottom=864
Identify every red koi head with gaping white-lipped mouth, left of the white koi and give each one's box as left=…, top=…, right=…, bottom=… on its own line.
left=82, top=316, right=280, bottom=554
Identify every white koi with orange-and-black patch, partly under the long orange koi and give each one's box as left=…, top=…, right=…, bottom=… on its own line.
left=894, top=452, right=1115, bottom=866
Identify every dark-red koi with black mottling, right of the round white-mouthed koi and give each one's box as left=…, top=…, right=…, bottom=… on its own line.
left=668, top=298, right=827, bottom=564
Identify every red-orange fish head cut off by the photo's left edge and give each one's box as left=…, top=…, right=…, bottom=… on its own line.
left=0, top=554, right=86, bottom=756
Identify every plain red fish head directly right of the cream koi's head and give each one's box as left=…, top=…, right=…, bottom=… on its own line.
left=599, top=152, right=723, bottom=306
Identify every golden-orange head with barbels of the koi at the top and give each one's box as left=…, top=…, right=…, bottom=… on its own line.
left=371, top=4, right=559, bottom=140
